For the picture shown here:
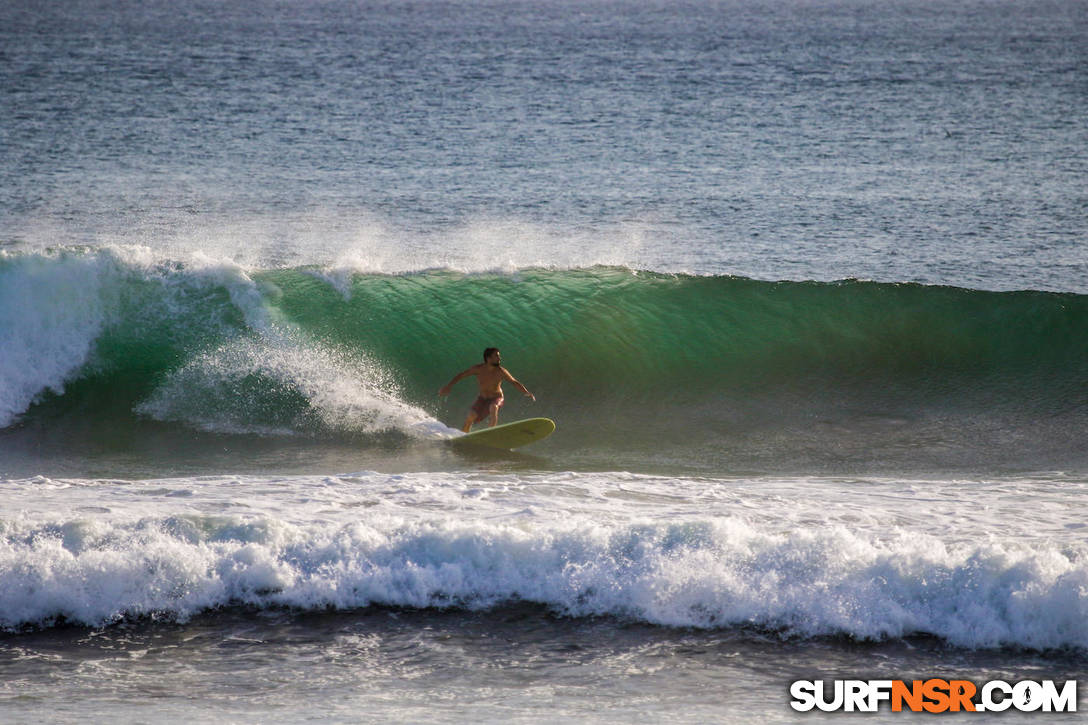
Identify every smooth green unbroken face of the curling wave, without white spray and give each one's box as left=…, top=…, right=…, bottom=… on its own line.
left=261, top=269, right=1088, bottom=404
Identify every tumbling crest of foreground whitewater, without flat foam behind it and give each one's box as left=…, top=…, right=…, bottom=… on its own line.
left=0, top=496, right=1088, bottom=649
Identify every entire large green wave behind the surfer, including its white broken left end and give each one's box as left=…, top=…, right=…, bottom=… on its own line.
left=0, top=253, right=1088, bottom=474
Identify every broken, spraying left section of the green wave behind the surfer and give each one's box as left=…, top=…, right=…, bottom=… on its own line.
left=0, top=248, right=443, bottom=434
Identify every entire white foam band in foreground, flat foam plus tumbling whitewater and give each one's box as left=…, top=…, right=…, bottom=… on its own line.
left=0, top=472, right=1088, bottom=648
